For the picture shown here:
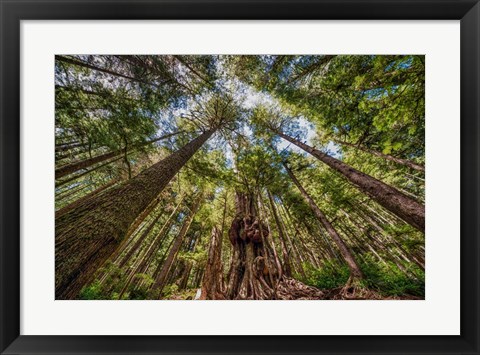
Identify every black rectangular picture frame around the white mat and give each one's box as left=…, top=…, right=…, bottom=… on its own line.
left=0, top=0, right=480, bottom=354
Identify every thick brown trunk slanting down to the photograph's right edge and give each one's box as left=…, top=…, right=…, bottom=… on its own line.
left=275, top=130, right=425, bottom=232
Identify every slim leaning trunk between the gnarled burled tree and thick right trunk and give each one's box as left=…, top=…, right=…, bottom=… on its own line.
left=284, top=164, right=363, bottom=283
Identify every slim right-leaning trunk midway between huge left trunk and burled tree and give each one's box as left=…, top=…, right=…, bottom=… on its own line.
left=153, top=193, right=203, bottom=296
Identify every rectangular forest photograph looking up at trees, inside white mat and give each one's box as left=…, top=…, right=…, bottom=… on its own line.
left=52, top=54, right=425, bottom=301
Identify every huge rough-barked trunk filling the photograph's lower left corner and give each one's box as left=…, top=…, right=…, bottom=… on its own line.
left=55, top=128, right=216, bottom=299
